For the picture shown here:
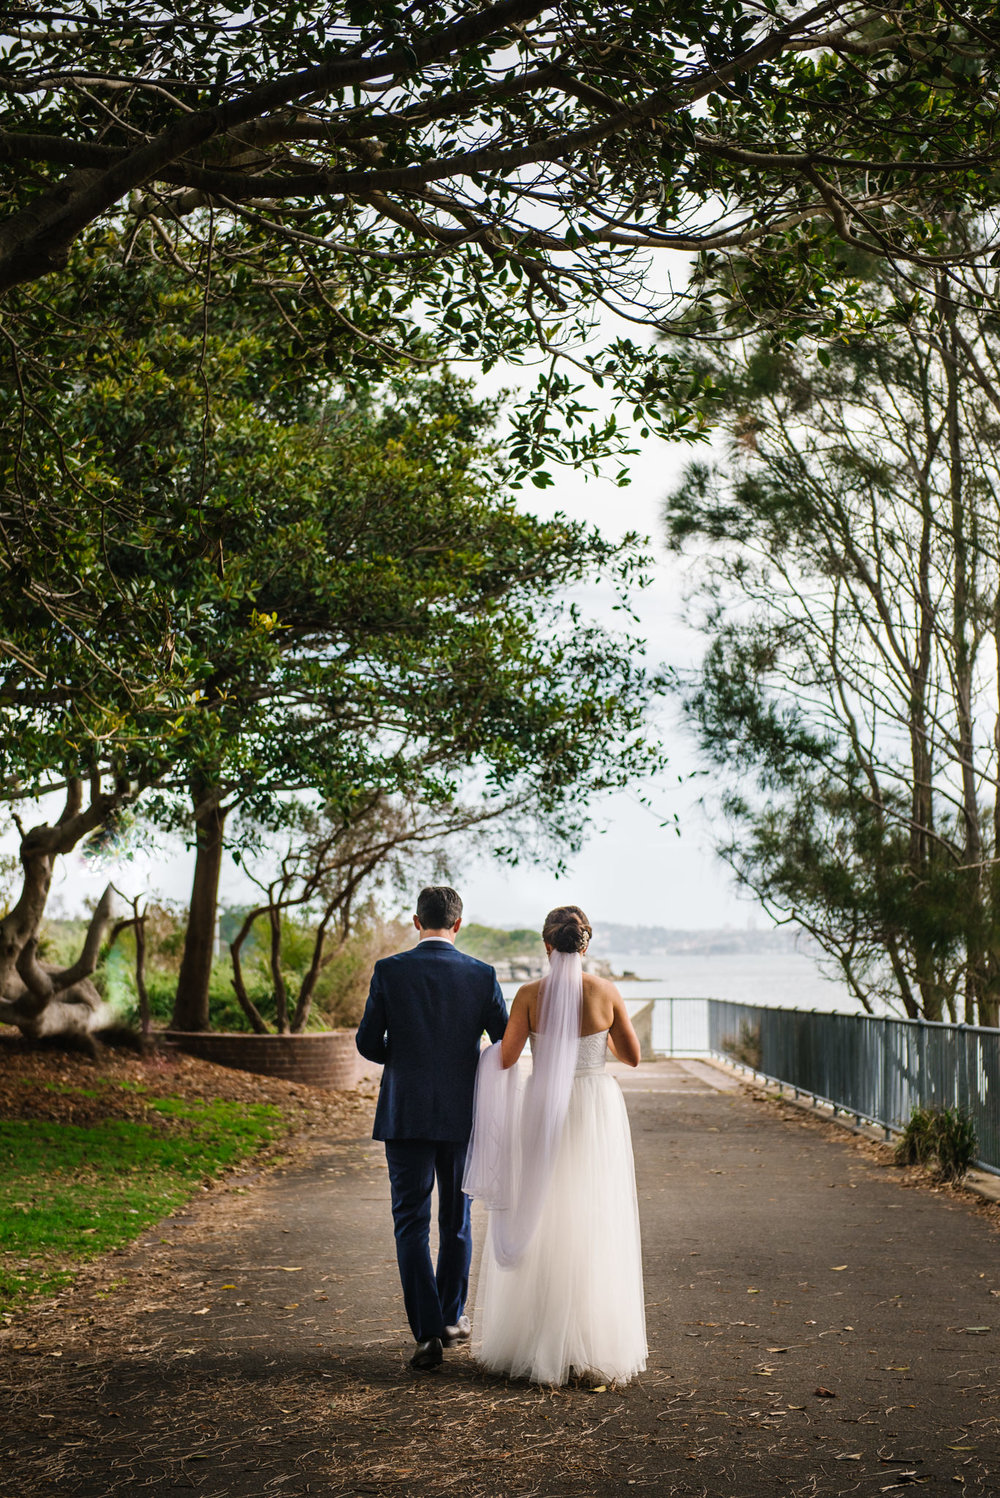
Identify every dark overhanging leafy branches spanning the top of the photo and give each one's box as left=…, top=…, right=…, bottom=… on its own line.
left=0, top=0, right=1000, bottom=452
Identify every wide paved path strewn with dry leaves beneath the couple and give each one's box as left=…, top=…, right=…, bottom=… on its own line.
left=0, top=1062, right=1000, bottom=1498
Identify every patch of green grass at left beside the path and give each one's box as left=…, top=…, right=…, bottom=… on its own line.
left=0, top=1089, right=289, bottom=1305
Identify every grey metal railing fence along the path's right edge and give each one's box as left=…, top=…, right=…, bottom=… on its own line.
left=708, top=999, right=1000, bottom=1174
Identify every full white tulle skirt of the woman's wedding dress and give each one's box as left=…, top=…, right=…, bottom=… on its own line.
left=473, top=1071, right=647, bottom=1384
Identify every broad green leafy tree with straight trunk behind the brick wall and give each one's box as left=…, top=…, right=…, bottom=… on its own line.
left=0, top=258, right=670, bottom=1028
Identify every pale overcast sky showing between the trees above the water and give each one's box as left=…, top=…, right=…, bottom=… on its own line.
left=19, top=404, right=760, bottom=927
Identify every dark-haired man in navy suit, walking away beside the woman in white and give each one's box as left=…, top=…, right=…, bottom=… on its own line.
left=356, top=884, right=507, bottom=1368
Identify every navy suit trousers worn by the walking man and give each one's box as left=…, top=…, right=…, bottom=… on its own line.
left=385, top=1138, right=472, bottom=1342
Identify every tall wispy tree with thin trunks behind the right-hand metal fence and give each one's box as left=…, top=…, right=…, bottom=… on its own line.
left=665, top=267, right=1000, bottom=1025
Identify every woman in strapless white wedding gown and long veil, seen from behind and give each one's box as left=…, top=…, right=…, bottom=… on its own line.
left=464, top=905, right=647, bottom=1384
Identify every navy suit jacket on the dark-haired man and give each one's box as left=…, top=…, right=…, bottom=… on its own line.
left=356, top=939, right=507, bottom=1143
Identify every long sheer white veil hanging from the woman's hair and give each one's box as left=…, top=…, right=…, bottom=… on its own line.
left=463, top=951, right=584, bottom=1269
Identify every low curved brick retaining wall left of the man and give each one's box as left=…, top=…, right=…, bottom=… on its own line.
left=163, top=1031, right=368, bottom=1092
